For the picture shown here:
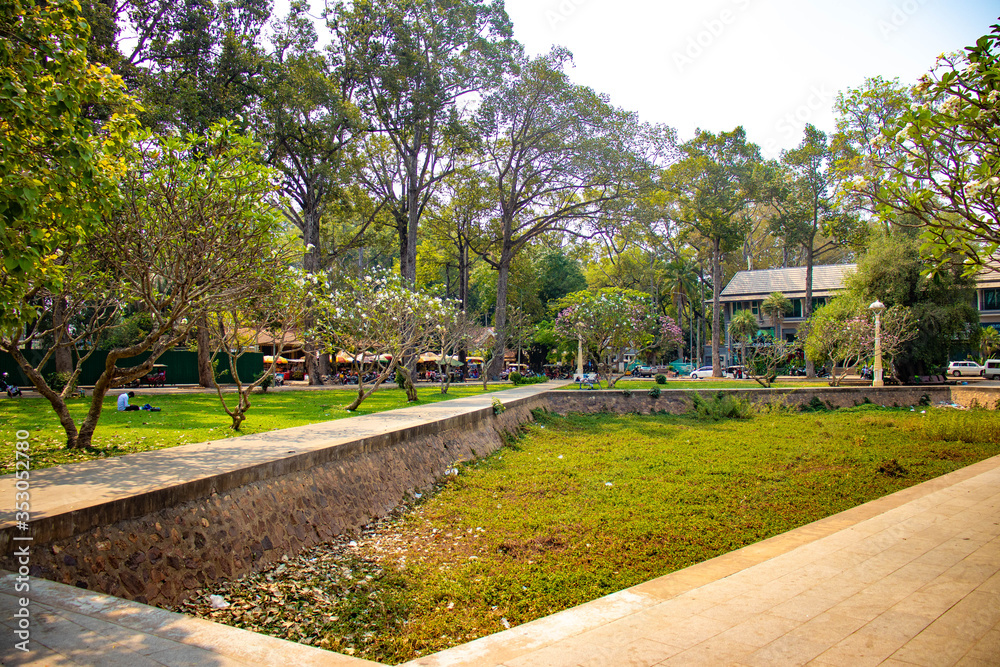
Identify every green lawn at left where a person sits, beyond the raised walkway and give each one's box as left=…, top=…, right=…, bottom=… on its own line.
left=0, top=383, right=500, bottom=475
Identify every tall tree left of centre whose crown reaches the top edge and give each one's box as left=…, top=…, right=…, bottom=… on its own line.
left=327, top=0, right=517, bottom=283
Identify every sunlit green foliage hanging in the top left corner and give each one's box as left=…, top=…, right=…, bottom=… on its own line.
left=0, top=0, right=137, bottom=328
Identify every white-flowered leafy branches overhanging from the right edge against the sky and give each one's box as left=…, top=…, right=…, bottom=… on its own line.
left=852, top=25, right=1000, bottom=266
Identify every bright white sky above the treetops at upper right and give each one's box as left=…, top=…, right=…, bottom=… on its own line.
left=506, top=0, right=1000, bottom=157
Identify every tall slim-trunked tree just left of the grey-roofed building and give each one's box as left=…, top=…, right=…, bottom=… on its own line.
left=662, top=127, right=761, bottom=377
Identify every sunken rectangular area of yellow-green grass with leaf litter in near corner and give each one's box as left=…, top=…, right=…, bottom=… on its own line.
left=181, top=405, right=1000, bottom=663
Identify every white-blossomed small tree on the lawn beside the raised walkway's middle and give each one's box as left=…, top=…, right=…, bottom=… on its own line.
left=310, top=272, right=438, bottom=411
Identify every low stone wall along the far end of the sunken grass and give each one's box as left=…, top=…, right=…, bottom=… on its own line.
left=546, top=385, right=960, bottom=414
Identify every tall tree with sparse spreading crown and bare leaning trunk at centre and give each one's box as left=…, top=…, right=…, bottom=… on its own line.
left=473, top=48, right=645, bottom=374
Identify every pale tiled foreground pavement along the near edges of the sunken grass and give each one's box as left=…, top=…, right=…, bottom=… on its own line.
left=0, top=384, right=1000, bottom=667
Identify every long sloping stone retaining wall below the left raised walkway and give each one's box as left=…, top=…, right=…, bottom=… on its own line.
left=0, top=395, right=545, bottom=605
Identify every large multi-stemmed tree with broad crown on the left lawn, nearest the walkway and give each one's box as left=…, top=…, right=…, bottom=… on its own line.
left=0, top=121, right=285, bottom=449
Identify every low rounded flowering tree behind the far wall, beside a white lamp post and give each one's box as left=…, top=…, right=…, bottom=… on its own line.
left=554, top=287, right=683, bottom=387
